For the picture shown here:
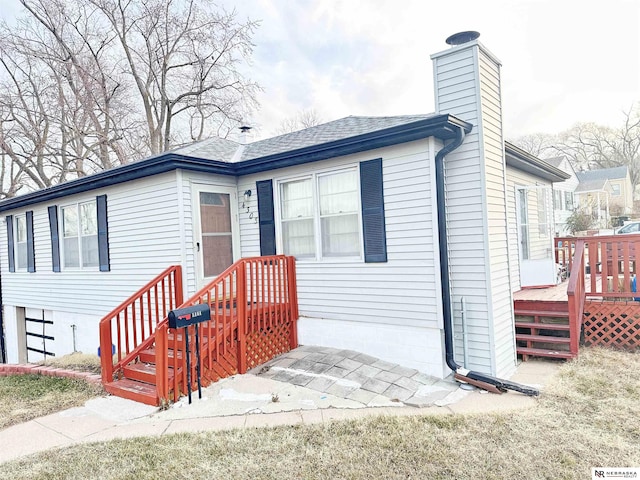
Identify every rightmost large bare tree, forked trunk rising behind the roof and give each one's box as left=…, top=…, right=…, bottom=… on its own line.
left=89, top=0, right=258, bottom=154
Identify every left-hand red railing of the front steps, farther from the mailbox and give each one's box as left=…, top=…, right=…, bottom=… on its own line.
left=100, top=265, right=183, bottom=382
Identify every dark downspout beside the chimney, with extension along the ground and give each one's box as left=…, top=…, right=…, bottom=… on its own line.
left=435, top=127, right=540, bottom=396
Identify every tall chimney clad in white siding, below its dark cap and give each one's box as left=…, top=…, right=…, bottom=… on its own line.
left=432, top=42, right=515, bottom=375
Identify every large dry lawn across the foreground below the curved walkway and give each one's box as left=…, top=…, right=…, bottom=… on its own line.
left=0, top=349, right=640, bottom=480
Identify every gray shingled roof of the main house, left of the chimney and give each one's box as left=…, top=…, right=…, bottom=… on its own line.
left=173, top=114, right=436, bottom=162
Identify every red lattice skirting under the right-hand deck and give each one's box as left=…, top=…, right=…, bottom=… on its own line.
left=583, top=301, right=640, bottom=349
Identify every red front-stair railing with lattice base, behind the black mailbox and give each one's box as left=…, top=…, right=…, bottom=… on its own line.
left=156, top=255, right=298, bottom=401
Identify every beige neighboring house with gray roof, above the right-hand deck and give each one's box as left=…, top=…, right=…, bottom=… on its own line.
left=575, top=166, right=633, bottom=228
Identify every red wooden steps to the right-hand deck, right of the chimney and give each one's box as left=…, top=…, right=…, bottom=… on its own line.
left=514, top=299, right=574, bottom=360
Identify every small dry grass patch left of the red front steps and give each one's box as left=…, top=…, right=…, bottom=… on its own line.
left=0, top=375, right=102, bottom=429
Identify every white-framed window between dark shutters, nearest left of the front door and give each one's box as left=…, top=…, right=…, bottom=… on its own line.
left=61, top=201, right=99, bottom=268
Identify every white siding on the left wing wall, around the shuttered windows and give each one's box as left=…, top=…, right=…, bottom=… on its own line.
left=0, top=172, right=181, bottom=316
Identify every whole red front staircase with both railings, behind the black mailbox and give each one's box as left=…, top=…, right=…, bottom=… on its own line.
left=100, top=255, right=298, bottom=405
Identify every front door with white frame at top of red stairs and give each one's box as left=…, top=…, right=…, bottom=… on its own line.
left=193, top=185, right=240, bottom=288
